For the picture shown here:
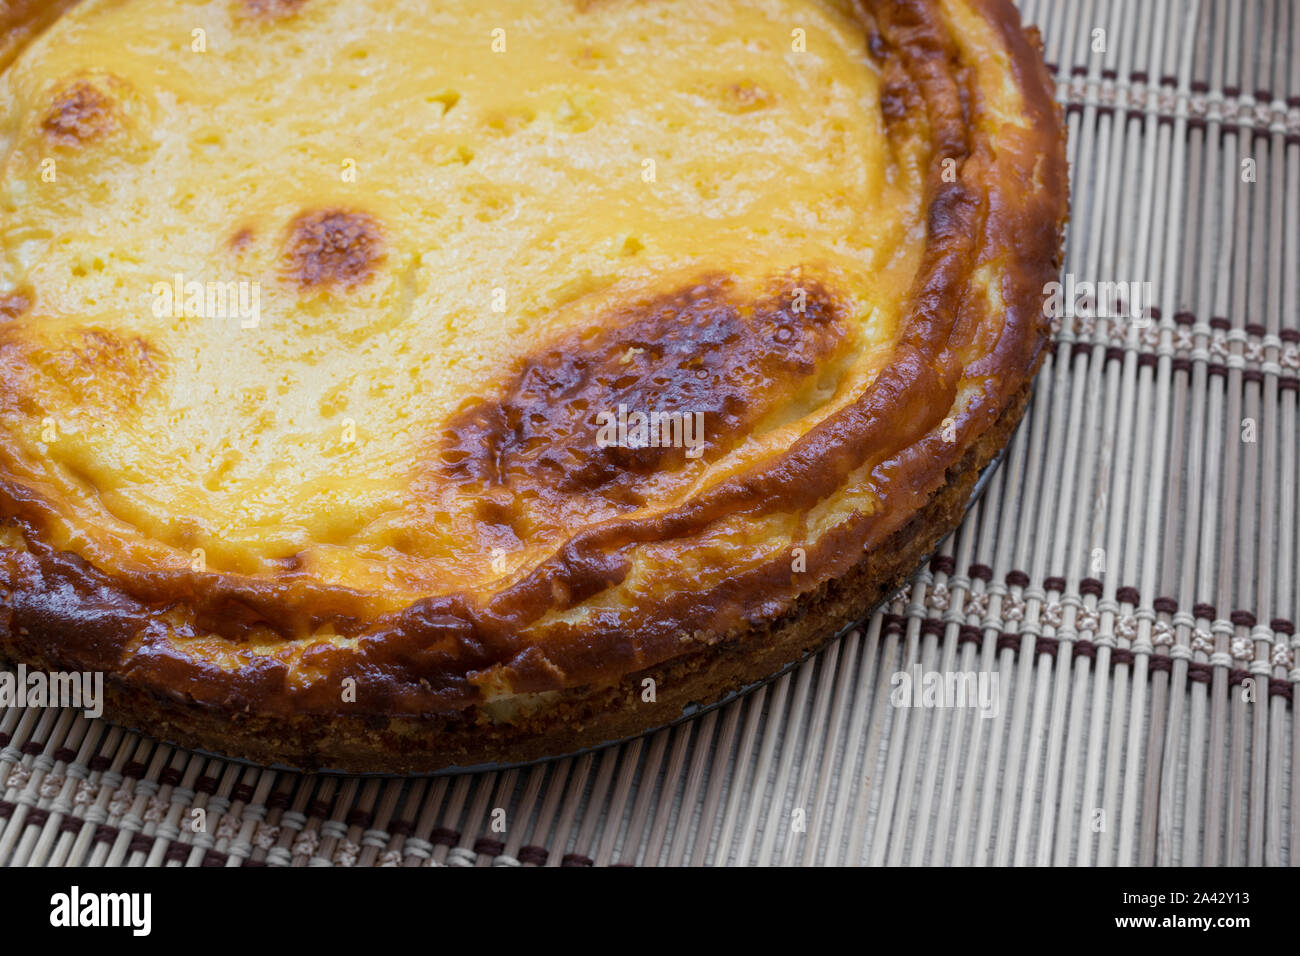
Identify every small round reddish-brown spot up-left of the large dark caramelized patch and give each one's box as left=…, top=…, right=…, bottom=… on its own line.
left=285, top=209, right=384, bottom=287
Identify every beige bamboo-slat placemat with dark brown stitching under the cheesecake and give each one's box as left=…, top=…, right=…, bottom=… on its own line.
left=0, top=0, right=1300, bottom=866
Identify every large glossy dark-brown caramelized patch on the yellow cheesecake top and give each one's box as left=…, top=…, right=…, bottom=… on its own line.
left=436, top=273, right=844, bottom=520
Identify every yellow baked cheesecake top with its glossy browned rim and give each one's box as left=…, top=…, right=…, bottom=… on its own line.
left=0, top=0, right=1065, bottom=713
